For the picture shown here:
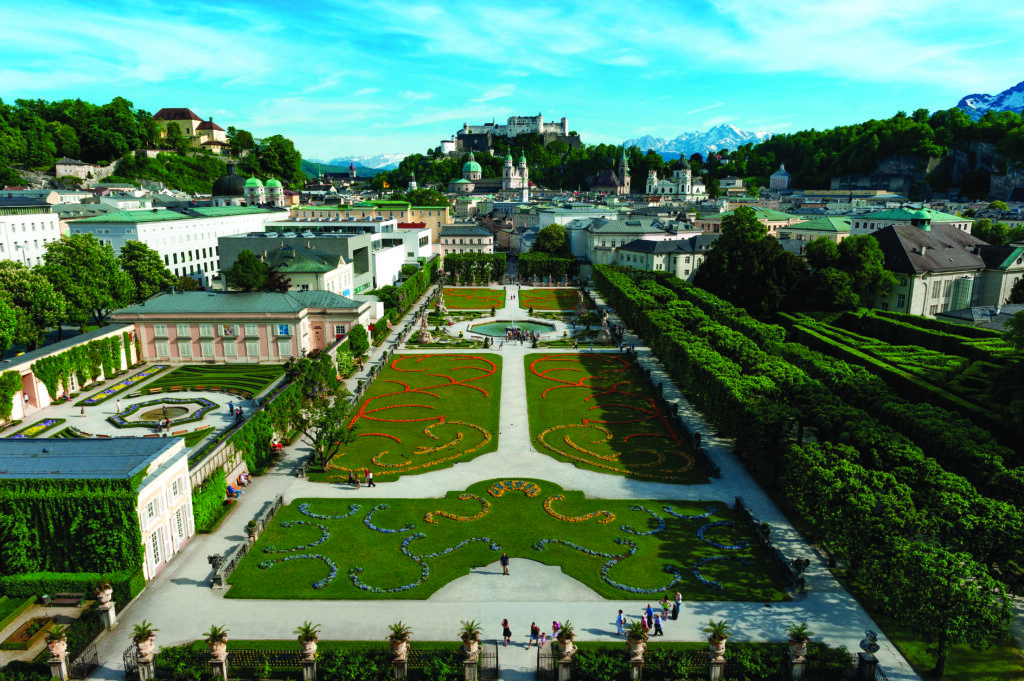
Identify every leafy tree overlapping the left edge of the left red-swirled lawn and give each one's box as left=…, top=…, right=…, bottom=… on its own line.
left=290, top=352, right=355, bottom=469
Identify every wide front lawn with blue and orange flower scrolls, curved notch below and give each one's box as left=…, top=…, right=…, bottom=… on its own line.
left=227, top=479, right=787, bottom=601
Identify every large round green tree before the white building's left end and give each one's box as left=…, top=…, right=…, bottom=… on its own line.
left=40, top=232, right=135, bottom=328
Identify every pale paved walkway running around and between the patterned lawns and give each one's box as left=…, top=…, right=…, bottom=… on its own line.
left=86, top=282, right=918, bottom=681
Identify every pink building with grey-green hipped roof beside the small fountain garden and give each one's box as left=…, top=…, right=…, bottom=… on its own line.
left=111, top=291, right=374, bottom=364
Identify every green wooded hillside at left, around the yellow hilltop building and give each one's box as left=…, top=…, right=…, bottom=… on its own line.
left=0, top=97, right=305, bottom=193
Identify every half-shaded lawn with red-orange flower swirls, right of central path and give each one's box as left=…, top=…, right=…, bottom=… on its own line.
left=524, top=352, right=709, bottom=483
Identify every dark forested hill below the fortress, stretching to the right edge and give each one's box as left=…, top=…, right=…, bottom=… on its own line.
left=377, top=109, right=1024, bottom=199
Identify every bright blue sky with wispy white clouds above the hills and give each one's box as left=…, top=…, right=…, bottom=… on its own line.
left=0, top=0, right=1024, bottom=160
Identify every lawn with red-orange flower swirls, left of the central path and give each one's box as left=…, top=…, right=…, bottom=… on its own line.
left=309, top=353, right=502, bottom=480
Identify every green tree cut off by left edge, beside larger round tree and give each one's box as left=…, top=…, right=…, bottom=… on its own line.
left=0, top=260, right=68, bottom=350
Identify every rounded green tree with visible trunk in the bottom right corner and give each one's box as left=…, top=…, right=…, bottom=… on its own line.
left=873, top=543, right=1013, bottom=679
